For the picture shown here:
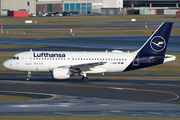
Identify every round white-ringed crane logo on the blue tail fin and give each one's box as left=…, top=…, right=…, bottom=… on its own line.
left=150, top=36, right=166, bottom=52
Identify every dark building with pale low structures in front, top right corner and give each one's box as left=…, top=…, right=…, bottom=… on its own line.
left=124, top=0, right=180, bottom=15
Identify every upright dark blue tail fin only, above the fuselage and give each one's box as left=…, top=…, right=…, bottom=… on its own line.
left=138, top=22, right=173, bottom=55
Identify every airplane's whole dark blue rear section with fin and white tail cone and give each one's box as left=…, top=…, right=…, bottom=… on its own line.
left=124, top=22, right=175, bottom=71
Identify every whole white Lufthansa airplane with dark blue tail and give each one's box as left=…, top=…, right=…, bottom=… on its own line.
left=3, top=22, right=176, bottom=83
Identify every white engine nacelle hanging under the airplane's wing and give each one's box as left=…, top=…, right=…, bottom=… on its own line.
left=52, top=68, right=71, bottom=79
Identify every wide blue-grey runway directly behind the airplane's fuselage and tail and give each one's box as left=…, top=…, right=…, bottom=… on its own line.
left=0, top=35, right=180, bottom=52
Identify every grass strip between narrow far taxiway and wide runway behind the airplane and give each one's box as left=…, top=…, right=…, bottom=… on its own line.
left=0, top=27, right=180, bottom=37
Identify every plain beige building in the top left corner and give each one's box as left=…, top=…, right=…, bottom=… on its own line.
left=0, top=0, right=36, bottom=16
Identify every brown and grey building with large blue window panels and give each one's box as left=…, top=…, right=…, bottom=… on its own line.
left=36, top=0, right=94, bottom=14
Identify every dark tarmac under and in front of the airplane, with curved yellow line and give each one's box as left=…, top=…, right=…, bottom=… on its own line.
left=0, top=73, right=180, bottom=117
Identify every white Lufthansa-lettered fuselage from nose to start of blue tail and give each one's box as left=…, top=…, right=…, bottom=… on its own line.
left=3, top=51, right=137, bottom=73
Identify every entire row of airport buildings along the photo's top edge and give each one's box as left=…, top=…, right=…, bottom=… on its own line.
left=0, top=0, right=180, bottom=15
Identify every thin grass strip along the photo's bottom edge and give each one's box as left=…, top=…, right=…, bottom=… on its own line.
left=0, top=115, right=179, bottom=120
